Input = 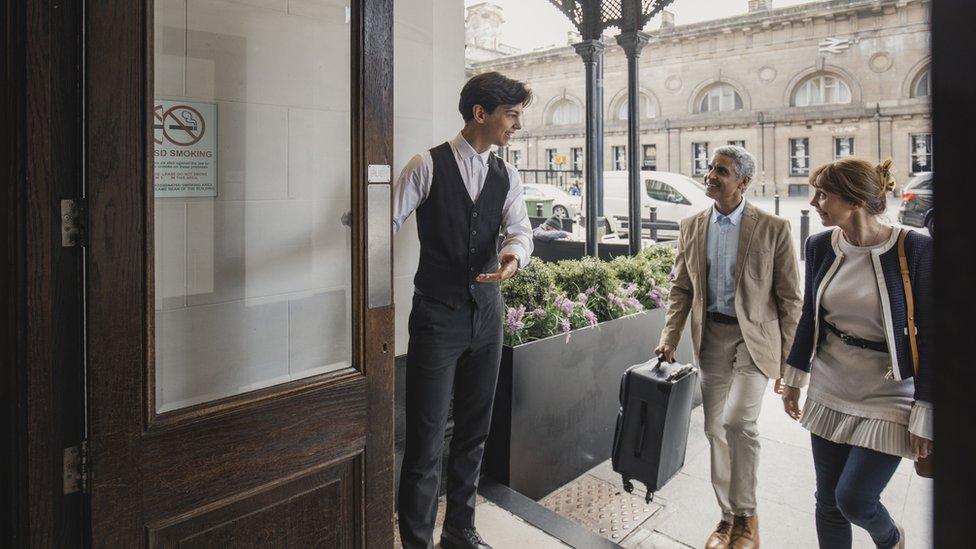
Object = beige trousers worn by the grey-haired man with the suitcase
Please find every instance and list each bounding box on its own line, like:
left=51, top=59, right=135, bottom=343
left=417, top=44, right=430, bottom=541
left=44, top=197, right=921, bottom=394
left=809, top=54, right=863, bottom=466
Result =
left=699, top=320, right=769, bottom=521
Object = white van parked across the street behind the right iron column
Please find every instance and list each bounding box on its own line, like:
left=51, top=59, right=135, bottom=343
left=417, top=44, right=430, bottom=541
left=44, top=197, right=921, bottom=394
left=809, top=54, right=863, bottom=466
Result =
left=603, top=170, right=712, bottom=231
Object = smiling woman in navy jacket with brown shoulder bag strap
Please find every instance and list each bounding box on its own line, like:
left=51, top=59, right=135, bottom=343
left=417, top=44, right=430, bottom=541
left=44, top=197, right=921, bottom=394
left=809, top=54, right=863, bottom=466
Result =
left=782, top=158, right=933, bottom=549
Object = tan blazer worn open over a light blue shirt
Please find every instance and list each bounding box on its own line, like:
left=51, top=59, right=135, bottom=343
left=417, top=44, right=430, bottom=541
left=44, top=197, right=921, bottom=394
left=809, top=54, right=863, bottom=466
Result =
left=661, top=202, right=803, bottom=379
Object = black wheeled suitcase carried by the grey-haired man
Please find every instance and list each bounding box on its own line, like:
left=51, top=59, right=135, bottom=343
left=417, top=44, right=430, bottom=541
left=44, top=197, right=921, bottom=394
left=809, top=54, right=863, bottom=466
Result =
left=611, top=357, right=698, bottom=501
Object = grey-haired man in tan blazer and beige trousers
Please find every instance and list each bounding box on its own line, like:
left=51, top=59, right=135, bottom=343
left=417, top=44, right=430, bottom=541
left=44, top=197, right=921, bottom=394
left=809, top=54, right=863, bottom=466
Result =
left=655, top=146, right=803, bottom=549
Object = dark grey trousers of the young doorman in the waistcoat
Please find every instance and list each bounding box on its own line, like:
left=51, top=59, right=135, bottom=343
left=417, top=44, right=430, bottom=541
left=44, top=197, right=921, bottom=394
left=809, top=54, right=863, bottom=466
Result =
left=397, top=294, right=504, bottom=549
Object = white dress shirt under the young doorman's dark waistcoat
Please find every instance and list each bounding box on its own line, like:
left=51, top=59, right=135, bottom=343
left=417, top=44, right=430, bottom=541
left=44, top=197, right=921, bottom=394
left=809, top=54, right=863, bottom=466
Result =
left=393, top=133, right=532, bottom=267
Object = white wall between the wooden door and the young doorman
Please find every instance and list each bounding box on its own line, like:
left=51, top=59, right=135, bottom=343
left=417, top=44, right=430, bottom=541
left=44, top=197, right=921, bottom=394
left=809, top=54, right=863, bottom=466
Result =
left=393, top=0, right=464, bottom=355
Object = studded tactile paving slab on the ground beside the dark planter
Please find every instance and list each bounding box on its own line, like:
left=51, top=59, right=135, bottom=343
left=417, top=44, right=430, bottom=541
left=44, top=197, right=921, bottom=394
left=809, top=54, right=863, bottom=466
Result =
left=541, top=475, right=661, bottom=542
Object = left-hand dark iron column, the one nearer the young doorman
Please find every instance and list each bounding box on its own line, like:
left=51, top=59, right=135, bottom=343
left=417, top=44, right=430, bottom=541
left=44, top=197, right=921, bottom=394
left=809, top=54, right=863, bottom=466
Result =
left=573, top=40, right=603, bottom=257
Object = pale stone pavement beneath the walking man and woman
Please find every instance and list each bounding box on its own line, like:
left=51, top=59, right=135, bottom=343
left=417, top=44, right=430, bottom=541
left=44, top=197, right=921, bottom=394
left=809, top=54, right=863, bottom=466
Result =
left=546, top=383, right=932, bottom=549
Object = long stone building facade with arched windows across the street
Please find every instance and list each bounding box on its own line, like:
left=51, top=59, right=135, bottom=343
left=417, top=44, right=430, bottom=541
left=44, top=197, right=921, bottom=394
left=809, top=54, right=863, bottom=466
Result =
left=468, top=0, right=933, bottom=195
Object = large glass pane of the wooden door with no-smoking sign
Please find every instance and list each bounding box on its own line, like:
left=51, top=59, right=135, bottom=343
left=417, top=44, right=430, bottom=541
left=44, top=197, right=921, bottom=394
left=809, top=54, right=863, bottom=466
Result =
left=153, top=0, right=352, bottom=413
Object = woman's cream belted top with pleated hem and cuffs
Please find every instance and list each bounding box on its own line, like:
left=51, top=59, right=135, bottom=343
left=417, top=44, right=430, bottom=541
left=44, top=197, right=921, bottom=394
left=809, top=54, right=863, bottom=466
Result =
left=784, top=225, right=932, bottom=458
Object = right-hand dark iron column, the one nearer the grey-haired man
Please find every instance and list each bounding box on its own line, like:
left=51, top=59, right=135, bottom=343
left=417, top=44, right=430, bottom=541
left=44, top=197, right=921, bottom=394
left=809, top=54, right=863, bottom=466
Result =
left=617, top=31, right=650, bottom=255
